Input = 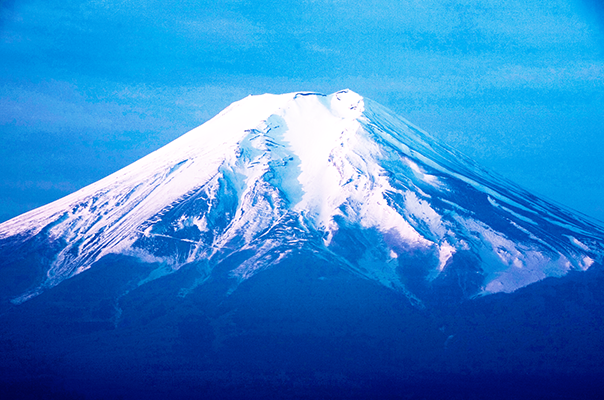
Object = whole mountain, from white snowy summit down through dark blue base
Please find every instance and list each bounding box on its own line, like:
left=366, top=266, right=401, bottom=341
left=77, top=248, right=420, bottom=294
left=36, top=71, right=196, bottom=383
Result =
left=0, top=90, right=604, bottom=398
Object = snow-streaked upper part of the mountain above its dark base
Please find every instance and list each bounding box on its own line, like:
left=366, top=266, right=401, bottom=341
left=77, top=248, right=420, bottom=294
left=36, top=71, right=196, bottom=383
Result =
left=0, top=90, right=604, bottom=304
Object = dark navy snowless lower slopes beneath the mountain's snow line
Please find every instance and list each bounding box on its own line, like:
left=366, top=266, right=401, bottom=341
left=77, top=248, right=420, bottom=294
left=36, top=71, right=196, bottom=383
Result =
left=0, top=256, right=604, bottom=400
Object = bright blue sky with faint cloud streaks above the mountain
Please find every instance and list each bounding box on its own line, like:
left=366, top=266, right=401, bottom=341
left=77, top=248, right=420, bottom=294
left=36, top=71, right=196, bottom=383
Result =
left=0, top=0, right=604, bottom=221
